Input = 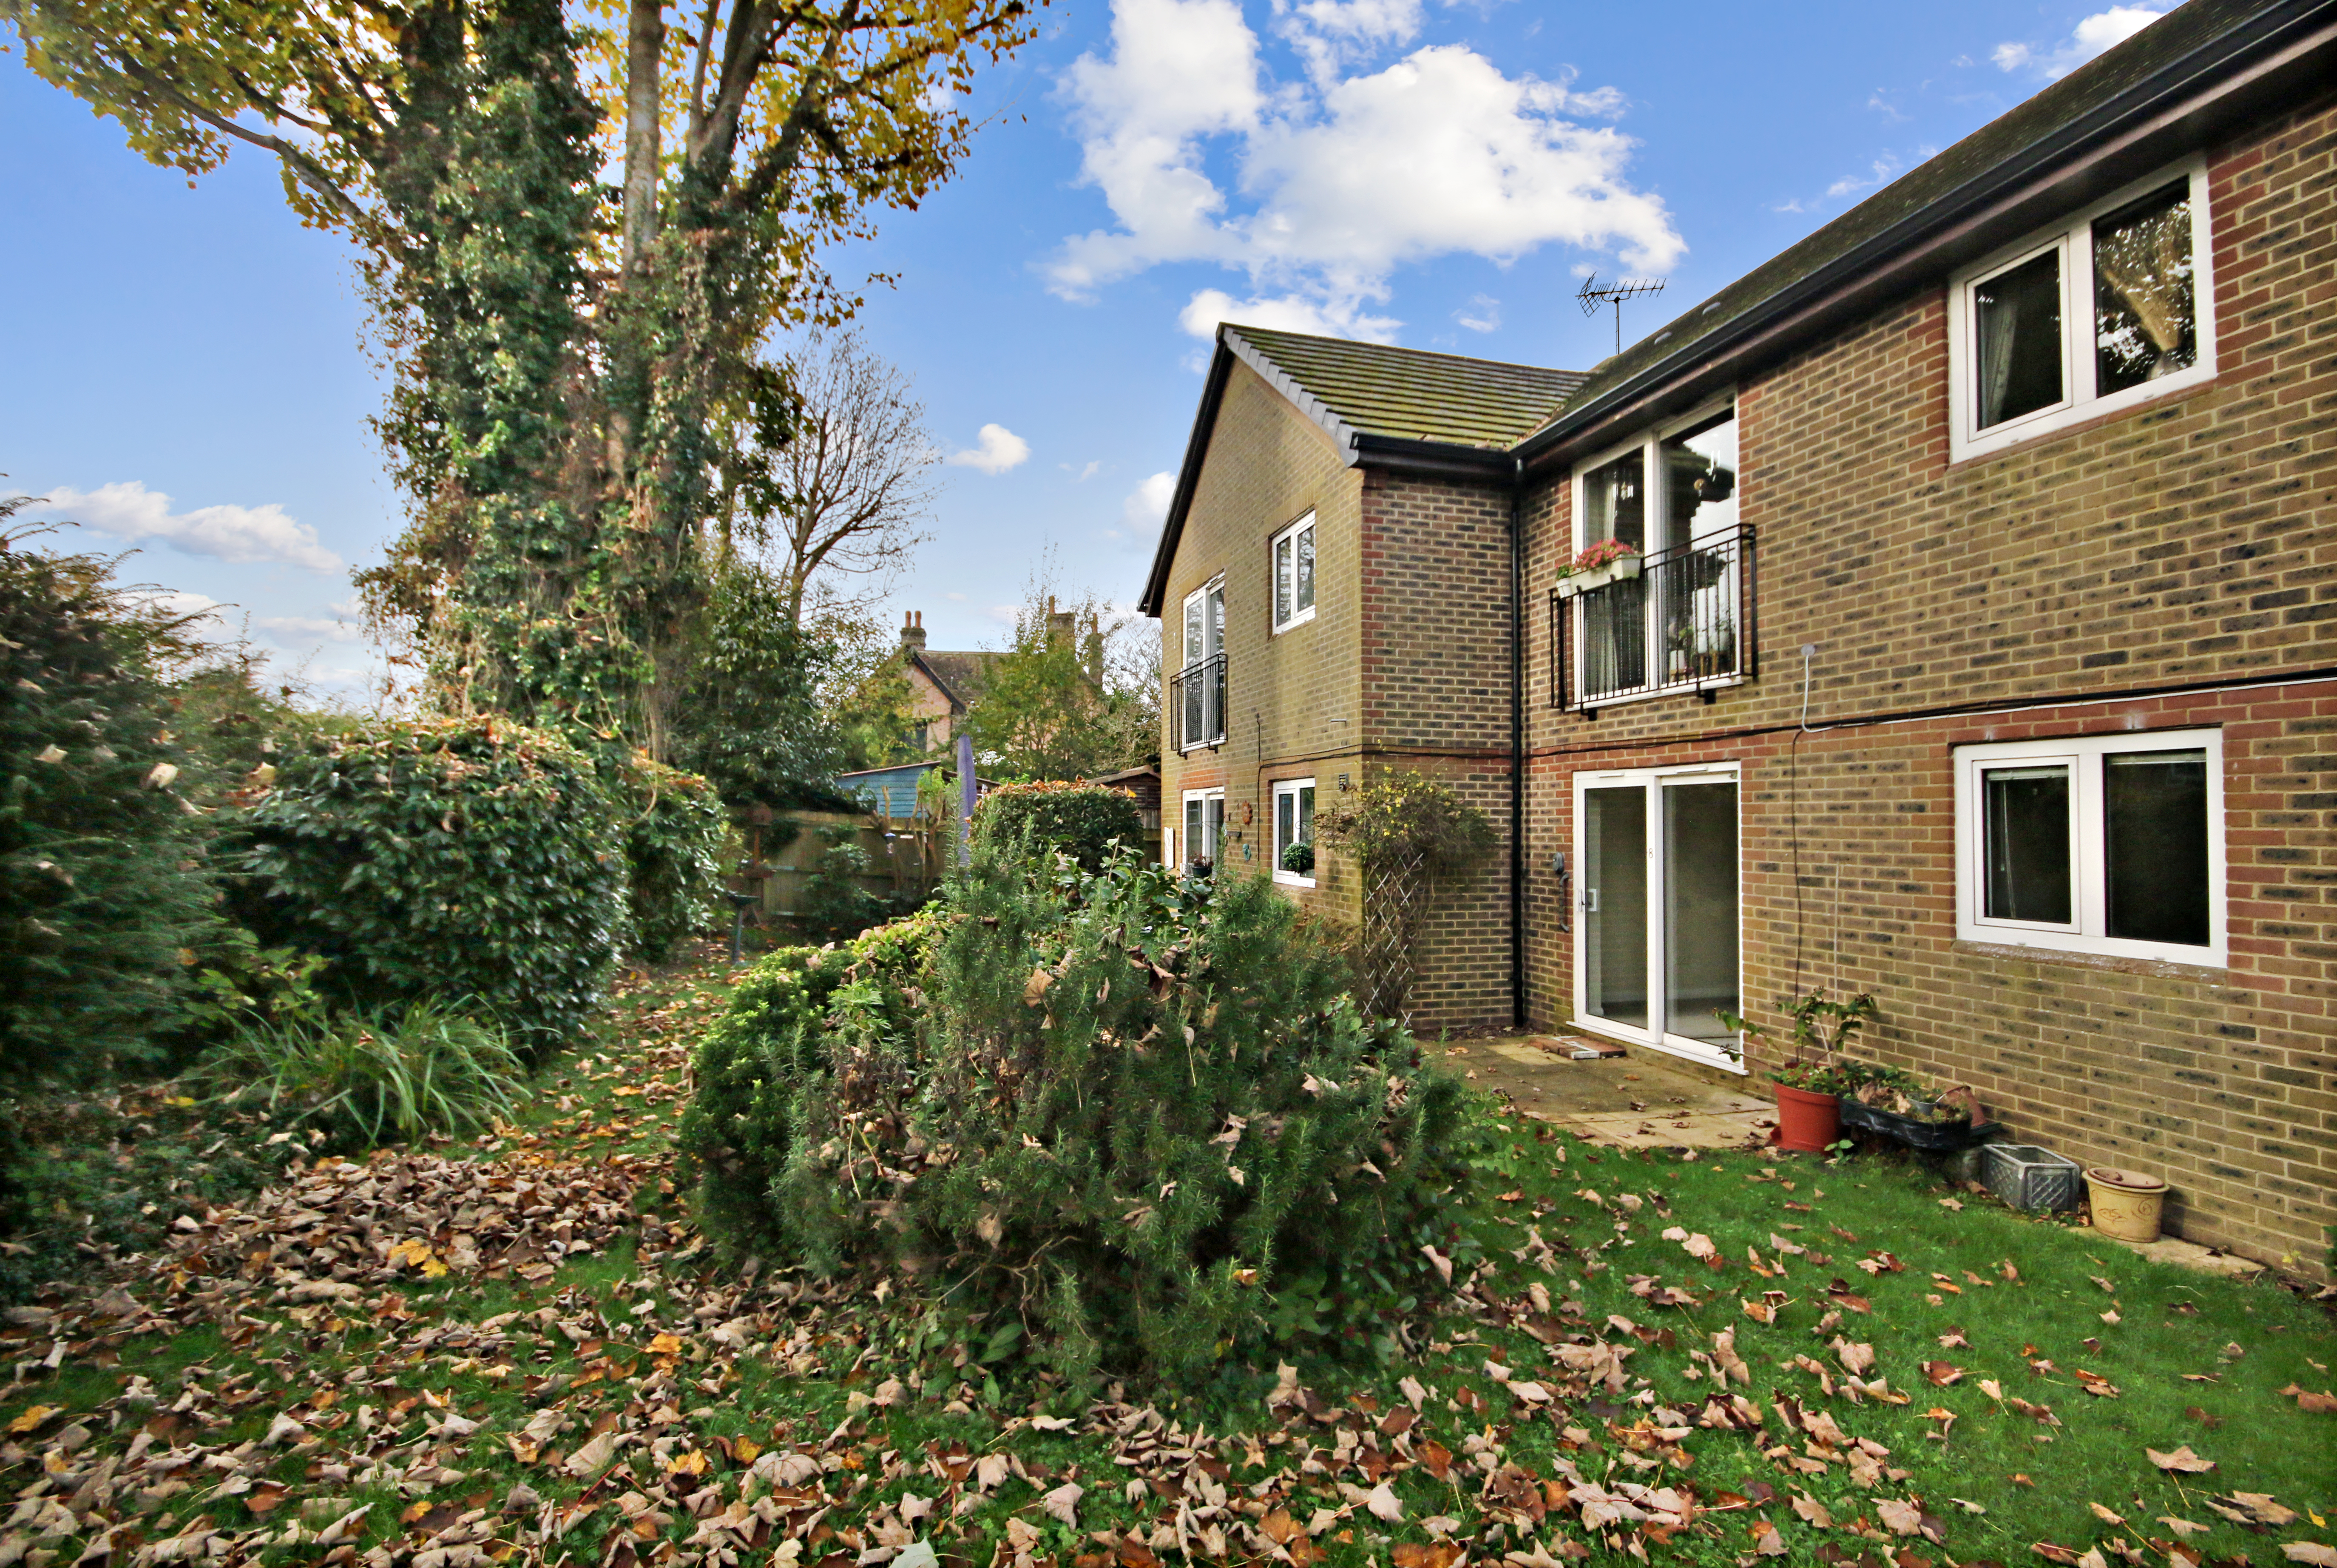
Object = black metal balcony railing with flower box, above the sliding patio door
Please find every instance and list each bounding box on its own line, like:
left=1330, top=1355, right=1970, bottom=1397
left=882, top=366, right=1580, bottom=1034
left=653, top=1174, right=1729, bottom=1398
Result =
left=1550, top=528, right=1760, bottom=713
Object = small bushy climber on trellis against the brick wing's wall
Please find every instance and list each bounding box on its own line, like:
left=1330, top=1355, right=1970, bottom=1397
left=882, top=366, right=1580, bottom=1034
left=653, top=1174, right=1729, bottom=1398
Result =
left=1316, top=769, right=1494, bottom=1017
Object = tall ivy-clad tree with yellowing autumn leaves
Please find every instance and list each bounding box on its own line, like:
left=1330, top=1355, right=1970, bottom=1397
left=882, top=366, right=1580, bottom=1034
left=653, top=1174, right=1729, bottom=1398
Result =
left=0, top=0, right=1031, bottom=753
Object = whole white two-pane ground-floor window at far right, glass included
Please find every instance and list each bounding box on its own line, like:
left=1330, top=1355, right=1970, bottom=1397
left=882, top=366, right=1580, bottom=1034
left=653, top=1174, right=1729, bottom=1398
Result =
left=1956, top=729, right=2229, bottom=967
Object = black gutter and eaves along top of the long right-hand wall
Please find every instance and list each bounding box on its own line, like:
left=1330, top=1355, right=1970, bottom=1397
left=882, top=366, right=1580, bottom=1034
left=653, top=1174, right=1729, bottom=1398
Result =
left=1514, top=0, right=2337, bottom=465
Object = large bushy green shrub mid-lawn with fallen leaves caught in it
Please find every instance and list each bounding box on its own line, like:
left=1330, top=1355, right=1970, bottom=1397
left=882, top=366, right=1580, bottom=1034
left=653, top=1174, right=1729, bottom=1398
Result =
left=685, top=844, right=1475, bottom=1376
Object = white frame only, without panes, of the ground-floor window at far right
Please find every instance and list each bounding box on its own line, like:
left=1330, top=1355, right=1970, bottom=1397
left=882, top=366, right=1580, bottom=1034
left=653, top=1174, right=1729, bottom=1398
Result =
left=1956, top=729, right=2232, bottom=970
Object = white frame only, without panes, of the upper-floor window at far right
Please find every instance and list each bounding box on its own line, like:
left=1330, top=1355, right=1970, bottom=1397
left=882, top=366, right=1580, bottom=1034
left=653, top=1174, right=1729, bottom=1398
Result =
left=1947, top=156, right=2215, bottom=463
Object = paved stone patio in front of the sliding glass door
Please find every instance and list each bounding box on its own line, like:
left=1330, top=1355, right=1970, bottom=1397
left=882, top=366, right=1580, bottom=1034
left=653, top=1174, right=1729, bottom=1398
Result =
left=1430, top=1035, right=1776, bottom=1150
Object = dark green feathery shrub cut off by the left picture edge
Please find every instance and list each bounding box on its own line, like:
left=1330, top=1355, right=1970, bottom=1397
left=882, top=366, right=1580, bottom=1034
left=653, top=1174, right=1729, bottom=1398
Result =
left=0, top=519, right=220, bottom=1087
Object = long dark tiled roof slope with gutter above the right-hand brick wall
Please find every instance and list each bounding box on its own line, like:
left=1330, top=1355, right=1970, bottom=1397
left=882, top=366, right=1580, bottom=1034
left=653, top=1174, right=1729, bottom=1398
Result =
left=1524, top=0, right=2337, bottom=458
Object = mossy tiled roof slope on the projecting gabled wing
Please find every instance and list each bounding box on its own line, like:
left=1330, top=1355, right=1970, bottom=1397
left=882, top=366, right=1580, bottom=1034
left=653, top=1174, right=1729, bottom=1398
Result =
left=1220, top=325, right=1582, bottom=451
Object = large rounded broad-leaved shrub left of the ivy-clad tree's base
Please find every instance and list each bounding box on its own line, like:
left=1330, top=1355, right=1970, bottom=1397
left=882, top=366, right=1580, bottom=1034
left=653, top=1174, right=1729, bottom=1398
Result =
left=236, top=717, right=626, bottom=1051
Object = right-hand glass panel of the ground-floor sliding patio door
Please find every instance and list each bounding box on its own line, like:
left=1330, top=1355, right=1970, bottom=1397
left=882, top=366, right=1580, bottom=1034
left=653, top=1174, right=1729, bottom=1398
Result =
left=1657, top=781, right=1744, bottom=1047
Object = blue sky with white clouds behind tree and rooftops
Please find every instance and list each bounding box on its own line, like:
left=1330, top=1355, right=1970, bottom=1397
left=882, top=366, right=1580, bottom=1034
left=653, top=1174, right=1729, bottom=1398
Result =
left=0, top=0, right=2167, bottom=685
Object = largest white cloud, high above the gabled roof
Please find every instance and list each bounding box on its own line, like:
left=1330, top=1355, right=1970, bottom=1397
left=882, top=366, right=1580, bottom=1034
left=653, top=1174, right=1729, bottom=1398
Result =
left=1047, top=0, right=1685, bottom=336
